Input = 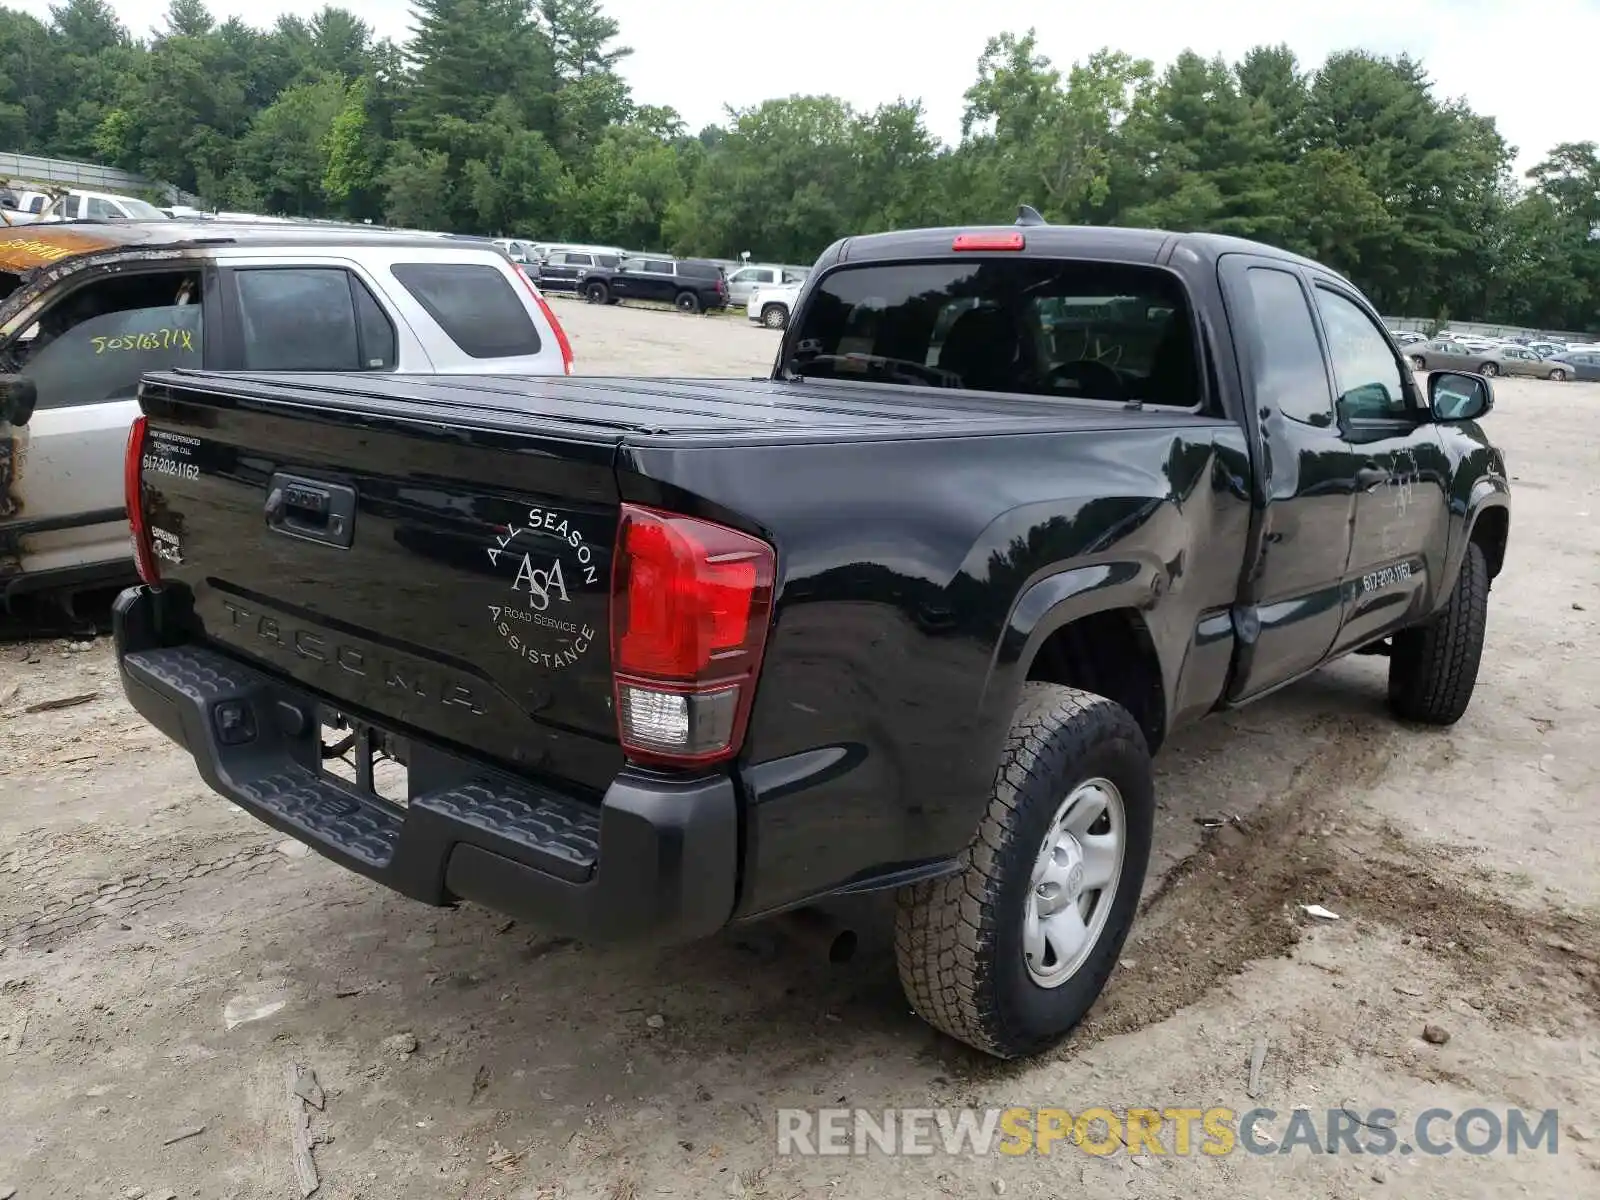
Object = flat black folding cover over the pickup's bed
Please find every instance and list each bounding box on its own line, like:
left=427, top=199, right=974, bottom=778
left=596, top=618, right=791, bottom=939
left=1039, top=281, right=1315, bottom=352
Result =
left=149, top=371, right=1211, bottom=445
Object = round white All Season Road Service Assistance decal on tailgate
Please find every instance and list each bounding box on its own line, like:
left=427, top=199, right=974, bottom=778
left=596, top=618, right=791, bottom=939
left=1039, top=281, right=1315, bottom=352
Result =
left=486, top=509, right=602, bottom=670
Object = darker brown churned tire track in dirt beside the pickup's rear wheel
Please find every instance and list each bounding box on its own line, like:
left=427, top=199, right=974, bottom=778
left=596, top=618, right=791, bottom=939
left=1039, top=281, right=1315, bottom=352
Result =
left=1066, top=717, right=1600, bottom=1053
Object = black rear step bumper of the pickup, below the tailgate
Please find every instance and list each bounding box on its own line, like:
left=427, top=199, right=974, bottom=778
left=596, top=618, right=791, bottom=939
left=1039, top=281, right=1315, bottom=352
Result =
left=114, top=587, right=739, bottom=942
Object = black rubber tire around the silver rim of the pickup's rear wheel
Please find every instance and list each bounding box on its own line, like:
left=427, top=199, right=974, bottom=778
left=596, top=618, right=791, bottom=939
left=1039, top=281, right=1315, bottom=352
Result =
left=894, top=683, right=1155, bottom=1058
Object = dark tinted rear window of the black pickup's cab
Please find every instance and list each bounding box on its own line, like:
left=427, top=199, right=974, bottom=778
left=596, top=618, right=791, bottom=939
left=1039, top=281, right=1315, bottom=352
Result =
left=784, top=259, right=1200, bottom=408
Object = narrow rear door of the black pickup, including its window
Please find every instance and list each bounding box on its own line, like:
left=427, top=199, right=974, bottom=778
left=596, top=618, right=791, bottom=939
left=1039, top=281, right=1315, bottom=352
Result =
left=1219, top=254, right=1355, bottom=702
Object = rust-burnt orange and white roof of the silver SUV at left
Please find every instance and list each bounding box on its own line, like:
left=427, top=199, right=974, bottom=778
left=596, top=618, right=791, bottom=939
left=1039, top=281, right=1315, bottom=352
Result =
left=0, top=218, right=459, bottom=272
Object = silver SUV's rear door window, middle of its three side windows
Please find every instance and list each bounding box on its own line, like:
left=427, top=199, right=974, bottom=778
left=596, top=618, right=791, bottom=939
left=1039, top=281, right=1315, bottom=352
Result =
left=234, top=267, right=395, bottom=371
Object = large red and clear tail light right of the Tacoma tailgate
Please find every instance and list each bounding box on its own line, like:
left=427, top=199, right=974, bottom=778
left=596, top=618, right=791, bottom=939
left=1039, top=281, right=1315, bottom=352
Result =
left=611, top=504, right=776, bottom=766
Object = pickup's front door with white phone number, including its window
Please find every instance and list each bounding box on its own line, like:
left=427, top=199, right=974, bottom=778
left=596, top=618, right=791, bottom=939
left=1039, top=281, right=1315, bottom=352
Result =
left=1312, top=278, right=1450, bottom=651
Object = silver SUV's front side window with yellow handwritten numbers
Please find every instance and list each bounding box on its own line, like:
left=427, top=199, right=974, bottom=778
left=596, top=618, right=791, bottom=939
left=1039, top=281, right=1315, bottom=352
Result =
left=9, top=272, right=205, bottom=408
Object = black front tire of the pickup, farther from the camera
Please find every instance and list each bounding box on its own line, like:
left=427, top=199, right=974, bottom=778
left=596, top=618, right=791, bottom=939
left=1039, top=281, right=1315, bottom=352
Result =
left=1389, top=542, right=1490, bottom=725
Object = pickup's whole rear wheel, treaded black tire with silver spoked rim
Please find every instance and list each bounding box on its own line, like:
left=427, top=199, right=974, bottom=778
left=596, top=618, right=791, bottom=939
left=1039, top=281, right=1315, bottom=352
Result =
left=894, top=683, right=1155, bottom=1058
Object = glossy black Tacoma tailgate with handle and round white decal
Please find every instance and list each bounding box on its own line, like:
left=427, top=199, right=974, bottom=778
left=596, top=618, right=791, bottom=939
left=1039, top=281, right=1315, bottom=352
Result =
left=141, top=374, right=622, bottom=792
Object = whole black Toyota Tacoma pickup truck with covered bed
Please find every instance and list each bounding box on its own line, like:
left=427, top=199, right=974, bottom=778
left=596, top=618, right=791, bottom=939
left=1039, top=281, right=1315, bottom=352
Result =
left=115, top=214, right=1509, bottom=1056
